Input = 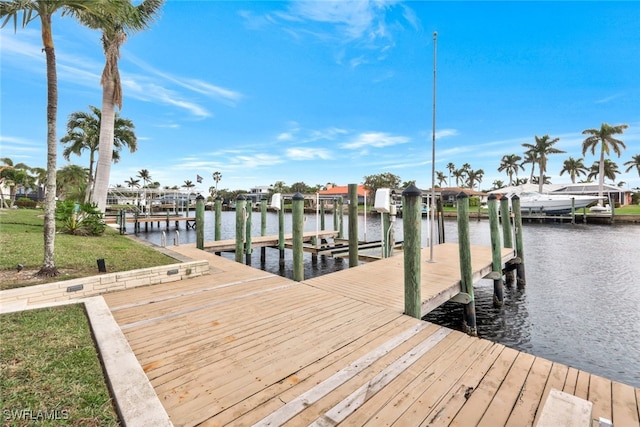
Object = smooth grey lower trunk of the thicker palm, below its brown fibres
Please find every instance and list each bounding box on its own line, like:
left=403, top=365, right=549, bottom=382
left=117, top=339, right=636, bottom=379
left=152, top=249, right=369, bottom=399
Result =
left=92, top=79, right=115, bottom=212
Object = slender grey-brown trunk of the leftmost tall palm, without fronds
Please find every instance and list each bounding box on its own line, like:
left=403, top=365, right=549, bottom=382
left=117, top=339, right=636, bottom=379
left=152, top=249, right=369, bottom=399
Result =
left=37, top=15, right=59, bottom=277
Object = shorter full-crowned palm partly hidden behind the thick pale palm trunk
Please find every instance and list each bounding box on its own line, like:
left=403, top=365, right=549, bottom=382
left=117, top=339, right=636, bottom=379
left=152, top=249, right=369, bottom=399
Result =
left=60, top=105, right=138, bottom=202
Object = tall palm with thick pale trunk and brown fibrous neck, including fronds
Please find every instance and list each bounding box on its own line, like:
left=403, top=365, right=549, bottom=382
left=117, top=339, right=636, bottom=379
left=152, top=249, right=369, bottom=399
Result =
left=90, top=0, right=164, bottom=211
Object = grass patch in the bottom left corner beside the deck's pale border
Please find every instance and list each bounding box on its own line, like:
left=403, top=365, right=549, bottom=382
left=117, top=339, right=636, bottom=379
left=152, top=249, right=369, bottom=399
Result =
left=0, top=304, right=120, bottom=426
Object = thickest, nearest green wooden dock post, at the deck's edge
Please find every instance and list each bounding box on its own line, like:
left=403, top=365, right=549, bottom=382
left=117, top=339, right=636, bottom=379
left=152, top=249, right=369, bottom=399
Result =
left=402, top=184, right=422, bottom=319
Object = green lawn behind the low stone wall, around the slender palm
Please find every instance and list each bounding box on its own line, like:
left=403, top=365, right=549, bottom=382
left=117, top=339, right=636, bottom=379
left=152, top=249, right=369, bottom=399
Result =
left=0, top=209, right=176, bottom=290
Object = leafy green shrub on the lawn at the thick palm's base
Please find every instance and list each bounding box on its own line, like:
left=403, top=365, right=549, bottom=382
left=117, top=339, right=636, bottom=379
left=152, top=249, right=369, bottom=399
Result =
left=56, top=200, right=106, bottom=236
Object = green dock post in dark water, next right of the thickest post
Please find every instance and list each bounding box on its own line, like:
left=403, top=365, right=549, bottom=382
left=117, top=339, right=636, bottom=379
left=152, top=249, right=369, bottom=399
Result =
left=457, top=192, right=478, bottom=337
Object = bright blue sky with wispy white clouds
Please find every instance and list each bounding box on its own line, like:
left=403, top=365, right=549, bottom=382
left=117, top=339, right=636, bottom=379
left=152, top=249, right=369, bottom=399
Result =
left=0, top=0, right=640, bottom=192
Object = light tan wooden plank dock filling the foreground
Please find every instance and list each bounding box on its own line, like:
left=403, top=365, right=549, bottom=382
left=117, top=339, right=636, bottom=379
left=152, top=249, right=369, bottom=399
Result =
left=104, top=244, right=640, bottom=426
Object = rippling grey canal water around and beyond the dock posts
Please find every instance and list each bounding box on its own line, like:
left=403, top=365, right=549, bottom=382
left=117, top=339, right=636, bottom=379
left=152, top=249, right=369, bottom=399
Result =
left=128, top=211, right=640, bottom=387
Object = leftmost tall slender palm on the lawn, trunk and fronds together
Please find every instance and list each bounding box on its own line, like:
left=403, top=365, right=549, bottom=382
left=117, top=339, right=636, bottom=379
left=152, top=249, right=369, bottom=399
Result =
left=0, top=0, right=120, bottom=277
